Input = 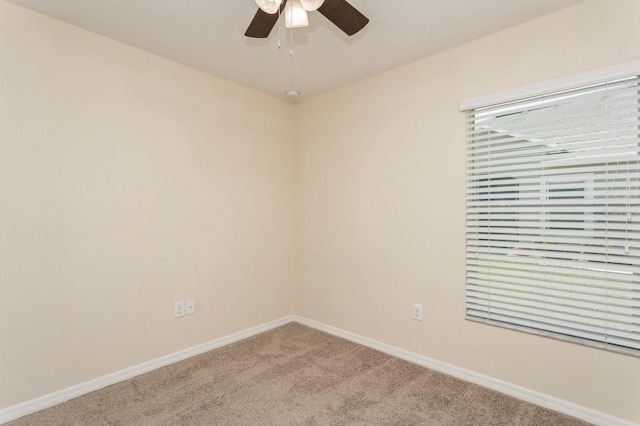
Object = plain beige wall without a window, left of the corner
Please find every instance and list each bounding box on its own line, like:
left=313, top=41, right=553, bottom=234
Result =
left=0, top=1, right=294, bottom=408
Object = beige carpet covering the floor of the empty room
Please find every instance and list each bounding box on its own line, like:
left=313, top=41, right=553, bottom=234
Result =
left=9, top=323, right=587, bottom=426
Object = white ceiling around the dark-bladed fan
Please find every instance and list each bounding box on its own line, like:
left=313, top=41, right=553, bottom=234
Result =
left=9, top=0, right=584, bottom=99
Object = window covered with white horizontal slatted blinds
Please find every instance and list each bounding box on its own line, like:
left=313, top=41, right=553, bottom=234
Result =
left=463, top=65, right=640, bottom=355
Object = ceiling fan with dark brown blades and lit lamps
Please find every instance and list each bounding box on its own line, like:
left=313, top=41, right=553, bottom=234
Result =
left=244, top=0, right=369, bottom=38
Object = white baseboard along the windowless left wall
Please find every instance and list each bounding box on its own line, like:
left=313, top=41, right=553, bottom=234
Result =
left=0, top=316, right=295, bottom=424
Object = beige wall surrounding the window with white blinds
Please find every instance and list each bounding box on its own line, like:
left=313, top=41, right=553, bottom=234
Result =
left=296, top=0, right=640, bottom=423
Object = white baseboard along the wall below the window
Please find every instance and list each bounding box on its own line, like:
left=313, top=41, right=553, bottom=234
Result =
left=294, top=316, right=637, bottom=426
